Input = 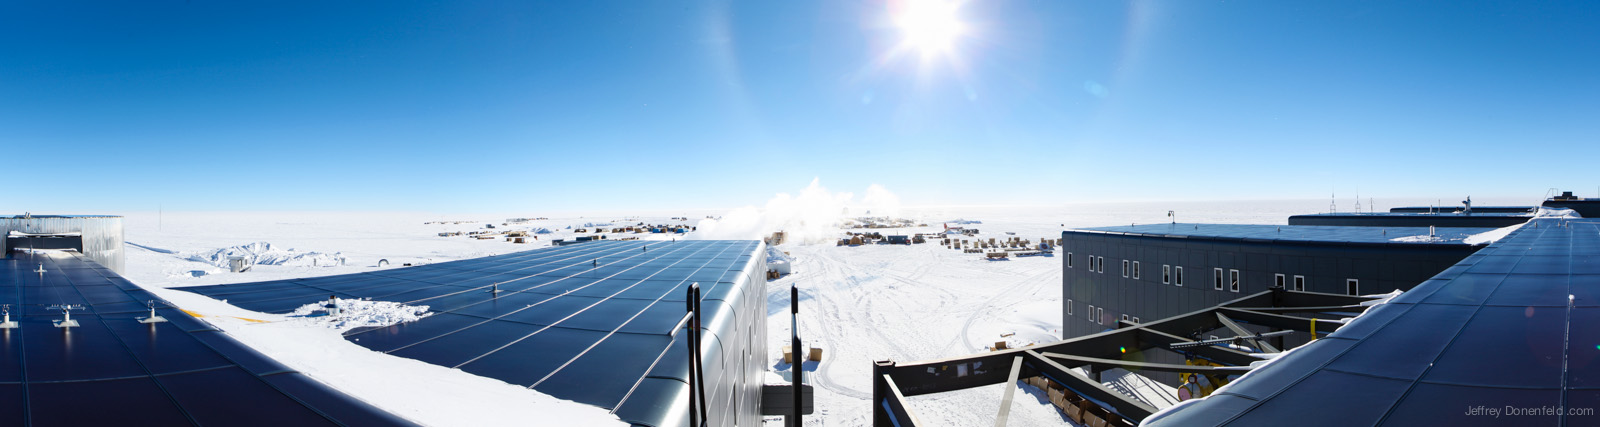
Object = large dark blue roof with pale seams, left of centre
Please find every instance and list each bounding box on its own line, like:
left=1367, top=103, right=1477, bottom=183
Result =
left=186, top=240, right=765, bottom=425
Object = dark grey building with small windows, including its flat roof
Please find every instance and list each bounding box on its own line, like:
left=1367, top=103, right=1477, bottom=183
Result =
left=1058, top=224, right=1493, bottom=384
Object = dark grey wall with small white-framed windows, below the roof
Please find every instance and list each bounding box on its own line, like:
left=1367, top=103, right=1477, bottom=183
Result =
left=1056, top=232, right=1482, bottom=385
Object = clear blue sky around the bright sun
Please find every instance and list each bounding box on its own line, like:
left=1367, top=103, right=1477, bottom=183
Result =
left=0, top=0, right=1600, bottom=213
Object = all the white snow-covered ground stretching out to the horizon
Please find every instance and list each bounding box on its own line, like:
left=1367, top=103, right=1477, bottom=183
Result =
left=103, top=195, right=1528, bottom=425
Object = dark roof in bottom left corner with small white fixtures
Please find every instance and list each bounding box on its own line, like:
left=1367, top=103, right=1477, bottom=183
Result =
left=0, top=253, right=411, bottom=425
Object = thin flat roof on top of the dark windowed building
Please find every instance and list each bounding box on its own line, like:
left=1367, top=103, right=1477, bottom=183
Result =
left=1067, top=222, right=1494, bottom=245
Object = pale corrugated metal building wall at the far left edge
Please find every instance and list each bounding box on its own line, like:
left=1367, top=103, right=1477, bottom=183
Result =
left=0, top=216, right=123, bottom=273
